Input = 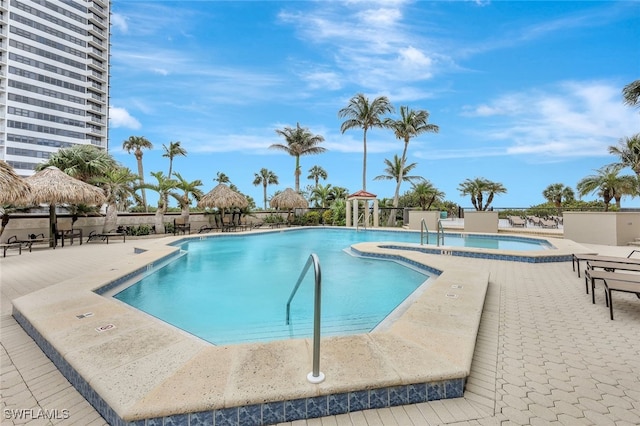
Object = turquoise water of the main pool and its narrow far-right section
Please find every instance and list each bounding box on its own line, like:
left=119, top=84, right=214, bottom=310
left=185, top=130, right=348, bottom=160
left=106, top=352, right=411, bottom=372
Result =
left=114, top=228, right=552, bottom=344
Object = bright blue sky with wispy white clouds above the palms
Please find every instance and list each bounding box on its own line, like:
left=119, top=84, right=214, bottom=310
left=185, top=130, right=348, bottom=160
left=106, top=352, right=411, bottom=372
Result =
left=109, top=0, right=640, bottom=207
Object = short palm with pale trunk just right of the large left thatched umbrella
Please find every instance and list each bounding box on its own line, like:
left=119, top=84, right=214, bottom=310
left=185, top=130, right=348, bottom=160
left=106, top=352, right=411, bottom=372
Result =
left=94, top=167, right=139, bottom=232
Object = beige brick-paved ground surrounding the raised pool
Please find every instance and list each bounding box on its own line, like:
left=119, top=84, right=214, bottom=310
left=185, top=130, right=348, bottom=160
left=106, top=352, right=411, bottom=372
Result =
left=0, top=235, right=640, bottom=426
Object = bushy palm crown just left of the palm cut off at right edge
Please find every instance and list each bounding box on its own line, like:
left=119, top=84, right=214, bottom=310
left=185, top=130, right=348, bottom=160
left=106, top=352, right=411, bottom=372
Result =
left=576, top=164, right=638, bottom=211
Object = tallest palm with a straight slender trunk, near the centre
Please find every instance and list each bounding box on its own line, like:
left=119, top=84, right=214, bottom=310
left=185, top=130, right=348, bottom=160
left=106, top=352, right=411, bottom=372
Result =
left=338, top=93, right=393, bottom=191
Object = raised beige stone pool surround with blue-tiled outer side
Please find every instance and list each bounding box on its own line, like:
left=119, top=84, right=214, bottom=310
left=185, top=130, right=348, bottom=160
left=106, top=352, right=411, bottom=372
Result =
left=8, top=228, right=592, bottom=424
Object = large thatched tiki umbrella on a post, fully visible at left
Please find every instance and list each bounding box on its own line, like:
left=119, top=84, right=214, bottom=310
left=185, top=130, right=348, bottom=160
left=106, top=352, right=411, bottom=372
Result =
left=26, top=166, right=106, bottom=247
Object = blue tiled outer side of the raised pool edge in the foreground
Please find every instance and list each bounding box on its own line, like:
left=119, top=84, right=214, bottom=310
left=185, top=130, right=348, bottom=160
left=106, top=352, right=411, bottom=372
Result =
left=13, top=308, right=466, bottom=426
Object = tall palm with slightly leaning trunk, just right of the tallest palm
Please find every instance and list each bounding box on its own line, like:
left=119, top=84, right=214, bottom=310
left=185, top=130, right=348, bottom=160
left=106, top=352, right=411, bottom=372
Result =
left=384, top=106, right=440, bottom=213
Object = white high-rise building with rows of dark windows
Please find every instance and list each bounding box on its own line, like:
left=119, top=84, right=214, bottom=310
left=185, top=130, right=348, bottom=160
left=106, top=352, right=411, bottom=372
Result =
left=0, top=0, right=110, bottom=176
